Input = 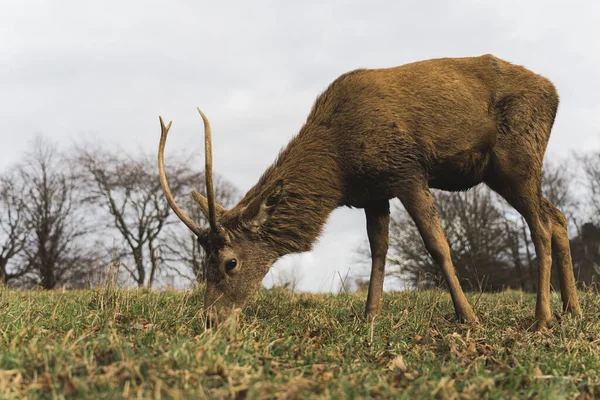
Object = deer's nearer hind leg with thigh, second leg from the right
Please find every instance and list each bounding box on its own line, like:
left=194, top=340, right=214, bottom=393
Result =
left=486, top=175, right=553, bottom=330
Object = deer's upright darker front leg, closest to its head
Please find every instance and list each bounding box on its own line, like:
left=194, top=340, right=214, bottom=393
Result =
left=365, top=200, right=390, bottom=319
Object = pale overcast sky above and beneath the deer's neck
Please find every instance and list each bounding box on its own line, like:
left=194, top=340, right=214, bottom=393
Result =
left=0, top=0, right=600, bottom=291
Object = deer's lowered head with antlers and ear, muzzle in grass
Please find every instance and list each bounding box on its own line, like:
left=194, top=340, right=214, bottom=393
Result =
left=158, top=109, right=283, bottom=326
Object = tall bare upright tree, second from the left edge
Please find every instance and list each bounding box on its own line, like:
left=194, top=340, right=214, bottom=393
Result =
left=19, top=138, right=96, bottom=289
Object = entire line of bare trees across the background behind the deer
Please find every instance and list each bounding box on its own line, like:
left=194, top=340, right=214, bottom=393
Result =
left=0, top=137, right=600, bottom=291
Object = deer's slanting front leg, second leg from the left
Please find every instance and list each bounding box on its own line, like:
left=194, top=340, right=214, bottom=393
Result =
left=399, top=185, right=477, bottom=323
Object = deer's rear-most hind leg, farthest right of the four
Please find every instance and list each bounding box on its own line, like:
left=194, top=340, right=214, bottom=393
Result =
left=542, top=198, right=581, bottom=316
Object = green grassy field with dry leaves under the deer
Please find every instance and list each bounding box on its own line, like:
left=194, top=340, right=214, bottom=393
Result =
left=0, top=288, right=600, bottom=399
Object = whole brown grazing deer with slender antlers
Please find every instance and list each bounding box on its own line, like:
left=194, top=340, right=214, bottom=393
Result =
left=158, top=54, right=581, bottom=329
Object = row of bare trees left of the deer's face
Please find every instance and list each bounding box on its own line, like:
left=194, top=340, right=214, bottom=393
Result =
left=0, top=137, right=239, bottom=289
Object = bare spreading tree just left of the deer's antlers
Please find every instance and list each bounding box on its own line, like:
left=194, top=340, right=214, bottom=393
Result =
left=77, top=148, right=217, bottom=287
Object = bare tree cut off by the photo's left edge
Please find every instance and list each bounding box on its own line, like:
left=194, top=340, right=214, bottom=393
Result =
left=0, top=173, right=29, bottom=284
